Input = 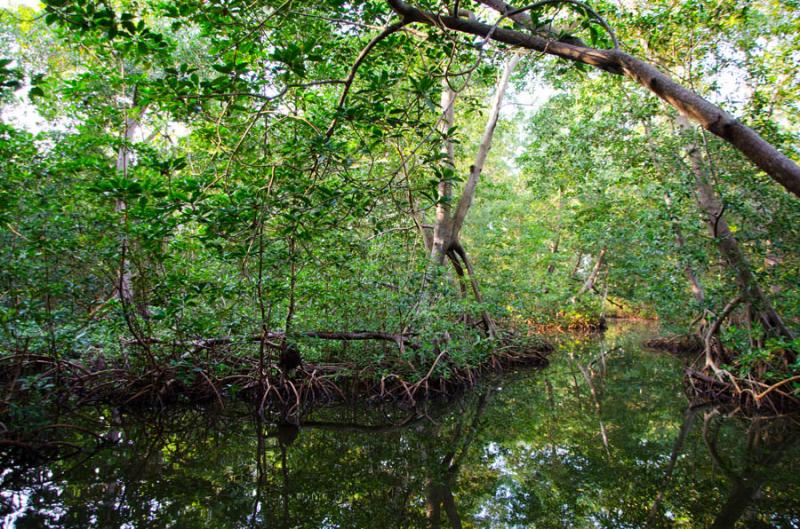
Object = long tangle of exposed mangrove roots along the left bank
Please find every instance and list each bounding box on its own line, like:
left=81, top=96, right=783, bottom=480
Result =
left=0, top=341, right=552, bottom=444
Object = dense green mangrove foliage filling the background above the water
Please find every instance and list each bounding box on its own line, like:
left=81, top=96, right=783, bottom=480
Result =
left=0, top=0, right=800, bottom=375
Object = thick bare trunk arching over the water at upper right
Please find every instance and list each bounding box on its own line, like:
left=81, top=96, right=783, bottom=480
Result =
left=387, top=0, right=800, bottom=197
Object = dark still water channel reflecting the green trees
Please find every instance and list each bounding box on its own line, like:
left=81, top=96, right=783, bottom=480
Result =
left=0, top=325, right=800, bottom=529
